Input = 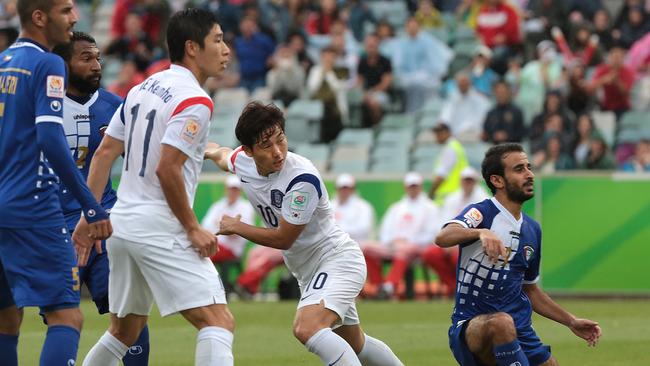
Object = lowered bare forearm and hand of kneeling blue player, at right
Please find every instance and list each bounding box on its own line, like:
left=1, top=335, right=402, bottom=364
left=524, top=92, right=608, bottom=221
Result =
left=523, top=284, right=602, bottom=346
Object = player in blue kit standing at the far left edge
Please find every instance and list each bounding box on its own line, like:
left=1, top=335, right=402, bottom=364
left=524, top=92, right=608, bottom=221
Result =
left=0, top=0, right=112, bottom=366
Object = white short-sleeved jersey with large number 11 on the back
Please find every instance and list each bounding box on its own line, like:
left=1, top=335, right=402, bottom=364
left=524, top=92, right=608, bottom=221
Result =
left=106, top=65, right=213, bottom=248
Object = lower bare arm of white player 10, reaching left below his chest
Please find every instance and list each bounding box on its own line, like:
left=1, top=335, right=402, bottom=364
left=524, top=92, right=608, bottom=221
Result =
left=217, top=215, right=307, bottom=250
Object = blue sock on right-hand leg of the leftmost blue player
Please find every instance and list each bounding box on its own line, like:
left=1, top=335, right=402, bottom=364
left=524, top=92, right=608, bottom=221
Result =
left=40, top=325, right=79, bottom=366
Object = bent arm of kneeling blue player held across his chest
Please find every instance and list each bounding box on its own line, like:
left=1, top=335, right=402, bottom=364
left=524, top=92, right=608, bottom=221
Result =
left=436, top=223, right=507, bottom=263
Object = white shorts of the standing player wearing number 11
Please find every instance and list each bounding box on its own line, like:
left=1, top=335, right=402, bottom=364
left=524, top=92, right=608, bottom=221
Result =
left=106, top=236, right=226, bottom=318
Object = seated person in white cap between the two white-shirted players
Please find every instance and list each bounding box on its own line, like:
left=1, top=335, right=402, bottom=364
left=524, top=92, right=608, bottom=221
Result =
left=201, top=175, right=255, bottom=264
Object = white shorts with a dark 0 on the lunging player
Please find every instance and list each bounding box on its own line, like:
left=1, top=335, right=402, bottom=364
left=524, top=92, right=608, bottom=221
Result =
left=298, top=241, right=366, bottom=328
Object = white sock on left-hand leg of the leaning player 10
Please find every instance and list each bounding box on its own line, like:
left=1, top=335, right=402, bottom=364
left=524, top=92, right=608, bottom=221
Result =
left=305, top=328, right=361, bottom=366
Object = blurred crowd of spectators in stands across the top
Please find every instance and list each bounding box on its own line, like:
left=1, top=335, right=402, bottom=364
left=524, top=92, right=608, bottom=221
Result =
left=0, top=0, right=650, bottom=176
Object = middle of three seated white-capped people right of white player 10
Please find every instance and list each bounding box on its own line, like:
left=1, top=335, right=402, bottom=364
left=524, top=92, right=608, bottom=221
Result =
left=363, top=172, right=442, bottom=297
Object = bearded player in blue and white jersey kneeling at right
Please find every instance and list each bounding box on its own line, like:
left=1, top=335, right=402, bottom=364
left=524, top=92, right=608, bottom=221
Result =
left=436, top=143, right=601, bottom=366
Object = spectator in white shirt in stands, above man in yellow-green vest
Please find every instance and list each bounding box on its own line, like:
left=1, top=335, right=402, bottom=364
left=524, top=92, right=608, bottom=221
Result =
left=439, top=71, right=492, bottom=142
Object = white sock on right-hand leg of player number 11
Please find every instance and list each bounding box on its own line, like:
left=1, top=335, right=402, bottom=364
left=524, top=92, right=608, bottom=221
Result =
left=194, top=327, right=235, bottom=366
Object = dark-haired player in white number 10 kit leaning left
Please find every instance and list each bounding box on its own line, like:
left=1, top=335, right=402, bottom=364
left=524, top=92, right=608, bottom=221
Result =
left=206, top=102, right=402, bottom=366
